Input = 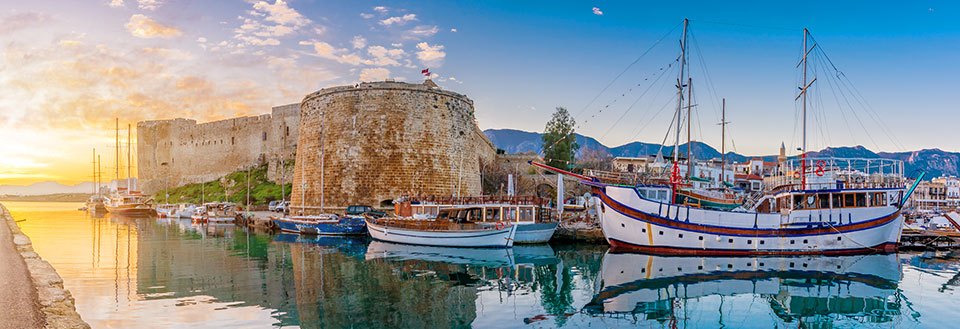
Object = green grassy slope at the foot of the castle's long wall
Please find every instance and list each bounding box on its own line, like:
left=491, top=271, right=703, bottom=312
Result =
left=153, top=165, right=292, bottom=205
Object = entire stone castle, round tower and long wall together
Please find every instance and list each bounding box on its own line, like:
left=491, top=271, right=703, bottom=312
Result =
left=137, top=80, right=496, bottom=210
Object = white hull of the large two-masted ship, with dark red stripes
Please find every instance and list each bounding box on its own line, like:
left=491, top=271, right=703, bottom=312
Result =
left=600, top=186, right=903, bottom=255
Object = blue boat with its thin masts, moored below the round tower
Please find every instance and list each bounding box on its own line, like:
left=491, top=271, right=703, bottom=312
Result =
left=272, top=107, right=367, bottom=235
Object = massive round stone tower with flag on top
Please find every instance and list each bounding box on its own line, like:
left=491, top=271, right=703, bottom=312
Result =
left=290, top=80, right=496, bottom=214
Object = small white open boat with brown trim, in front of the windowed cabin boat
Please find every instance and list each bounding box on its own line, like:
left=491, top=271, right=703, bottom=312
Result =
left=366, top=207, right=520, bottom=248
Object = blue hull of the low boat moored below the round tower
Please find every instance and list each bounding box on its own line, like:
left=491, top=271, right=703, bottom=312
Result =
left=272, top=214, right=367, bottom=235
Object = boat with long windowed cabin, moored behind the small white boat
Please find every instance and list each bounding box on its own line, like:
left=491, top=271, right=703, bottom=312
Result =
left=394, top=196, right=559, bottom=244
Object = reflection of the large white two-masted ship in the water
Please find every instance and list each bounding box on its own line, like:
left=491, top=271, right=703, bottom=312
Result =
left=584, top=253, right=901, bottom=327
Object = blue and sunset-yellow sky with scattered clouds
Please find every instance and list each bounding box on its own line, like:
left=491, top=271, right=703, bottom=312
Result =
left=0, top=0, right=960, bottom=184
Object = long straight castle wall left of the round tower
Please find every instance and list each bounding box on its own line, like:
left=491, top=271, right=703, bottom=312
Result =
left=137, top=104, right=300, bottom=193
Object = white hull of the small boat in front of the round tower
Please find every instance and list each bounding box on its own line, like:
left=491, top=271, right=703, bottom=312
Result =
left=367, top=220, right=517, bottom=248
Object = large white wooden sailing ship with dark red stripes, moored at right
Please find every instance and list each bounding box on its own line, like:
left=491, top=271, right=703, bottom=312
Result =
left=538, top=20, right=924, bottom=256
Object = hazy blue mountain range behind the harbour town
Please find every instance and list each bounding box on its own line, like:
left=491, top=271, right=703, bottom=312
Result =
left=483, top=129, right=960, bottom=179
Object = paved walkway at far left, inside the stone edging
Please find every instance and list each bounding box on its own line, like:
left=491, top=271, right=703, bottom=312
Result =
left=0, top=206, right=44, bottom=329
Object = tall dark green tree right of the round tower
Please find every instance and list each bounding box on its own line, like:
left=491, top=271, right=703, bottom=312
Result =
left=543, top=106, right=580, bottom=170
